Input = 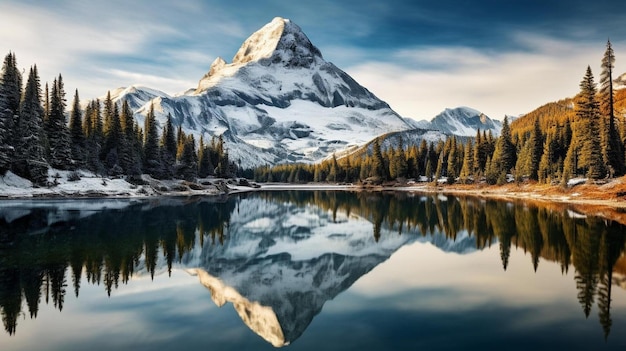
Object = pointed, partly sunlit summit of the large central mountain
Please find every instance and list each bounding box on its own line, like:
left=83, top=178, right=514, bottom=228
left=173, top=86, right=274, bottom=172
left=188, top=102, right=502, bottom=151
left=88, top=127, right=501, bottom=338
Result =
left=233, top=17, right=322, bottom=67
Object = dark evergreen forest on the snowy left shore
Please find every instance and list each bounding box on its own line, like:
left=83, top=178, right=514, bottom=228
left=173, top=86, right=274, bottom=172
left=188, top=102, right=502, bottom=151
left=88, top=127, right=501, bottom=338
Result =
left=0, top=53, right=237, bottom=186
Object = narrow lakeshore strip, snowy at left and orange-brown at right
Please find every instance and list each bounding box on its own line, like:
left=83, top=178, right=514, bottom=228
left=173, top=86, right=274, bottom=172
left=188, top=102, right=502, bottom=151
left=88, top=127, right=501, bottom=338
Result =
left=0, top=170, right=626, bottom=224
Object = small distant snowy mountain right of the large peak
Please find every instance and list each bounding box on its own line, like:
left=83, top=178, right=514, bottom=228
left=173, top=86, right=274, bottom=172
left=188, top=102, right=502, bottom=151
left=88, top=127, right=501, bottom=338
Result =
left=410, top=107, right=502, bottom=137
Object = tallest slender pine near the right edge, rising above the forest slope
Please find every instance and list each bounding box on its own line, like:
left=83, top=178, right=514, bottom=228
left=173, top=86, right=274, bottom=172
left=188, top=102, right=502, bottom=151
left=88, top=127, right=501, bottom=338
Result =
left=599, top=41, right=626, bottom=176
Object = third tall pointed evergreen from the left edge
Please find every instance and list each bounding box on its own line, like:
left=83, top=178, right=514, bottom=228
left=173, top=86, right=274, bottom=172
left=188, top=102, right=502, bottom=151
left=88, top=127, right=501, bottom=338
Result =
left=48, top=74, right=72, bottom=169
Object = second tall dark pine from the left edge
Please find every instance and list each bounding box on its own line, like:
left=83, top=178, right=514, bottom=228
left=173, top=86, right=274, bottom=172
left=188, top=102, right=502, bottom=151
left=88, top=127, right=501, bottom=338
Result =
left=14, top=66, right=48, bottom=185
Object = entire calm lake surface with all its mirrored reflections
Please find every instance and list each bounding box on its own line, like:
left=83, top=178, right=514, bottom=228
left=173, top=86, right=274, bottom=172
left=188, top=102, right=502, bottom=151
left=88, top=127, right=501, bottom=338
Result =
left=0, top=191, right=626, bottom=351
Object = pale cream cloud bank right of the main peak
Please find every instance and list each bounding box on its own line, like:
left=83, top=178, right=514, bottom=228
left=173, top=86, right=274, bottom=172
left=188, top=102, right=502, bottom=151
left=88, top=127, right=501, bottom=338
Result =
left=347, top=34, right=626, bottom=119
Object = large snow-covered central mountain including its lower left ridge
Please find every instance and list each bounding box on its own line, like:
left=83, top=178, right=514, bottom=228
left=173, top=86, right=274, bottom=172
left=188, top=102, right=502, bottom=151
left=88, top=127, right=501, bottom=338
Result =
left=106, top=17, right=412, bottom=167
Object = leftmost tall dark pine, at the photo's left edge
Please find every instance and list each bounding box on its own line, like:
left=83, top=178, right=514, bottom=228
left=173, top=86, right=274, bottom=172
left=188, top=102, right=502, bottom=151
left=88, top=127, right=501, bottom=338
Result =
left=0, top=53, right=22, bottom=174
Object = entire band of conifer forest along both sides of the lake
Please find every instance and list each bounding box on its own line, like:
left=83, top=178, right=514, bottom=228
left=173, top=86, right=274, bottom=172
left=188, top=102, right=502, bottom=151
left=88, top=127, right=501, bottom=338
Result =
left=0, top=41, right=626, bottom=186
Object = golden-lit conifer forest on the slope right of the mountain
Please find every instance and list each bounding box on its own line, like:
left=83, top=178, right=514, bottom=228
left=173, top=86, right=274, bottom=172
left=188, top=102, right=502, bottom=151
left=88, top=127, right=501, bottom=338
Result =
left=254, top=41, right=626, bottom=185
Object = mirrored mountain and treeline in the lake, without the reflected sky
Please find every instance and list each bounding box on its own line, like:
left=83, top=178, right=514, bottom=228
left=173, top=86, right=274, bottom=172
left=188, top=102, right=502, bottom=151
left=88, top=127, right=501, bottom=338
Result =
left=0, top=191, right=626, bottom=347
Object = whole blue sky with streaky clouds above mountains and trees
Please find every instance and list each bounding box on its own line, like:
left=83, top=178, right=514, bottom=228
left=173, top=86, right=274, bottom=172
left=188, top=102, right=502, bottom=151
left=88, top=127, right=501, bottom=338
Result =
left=0, top=0, right=626, bottom=119
